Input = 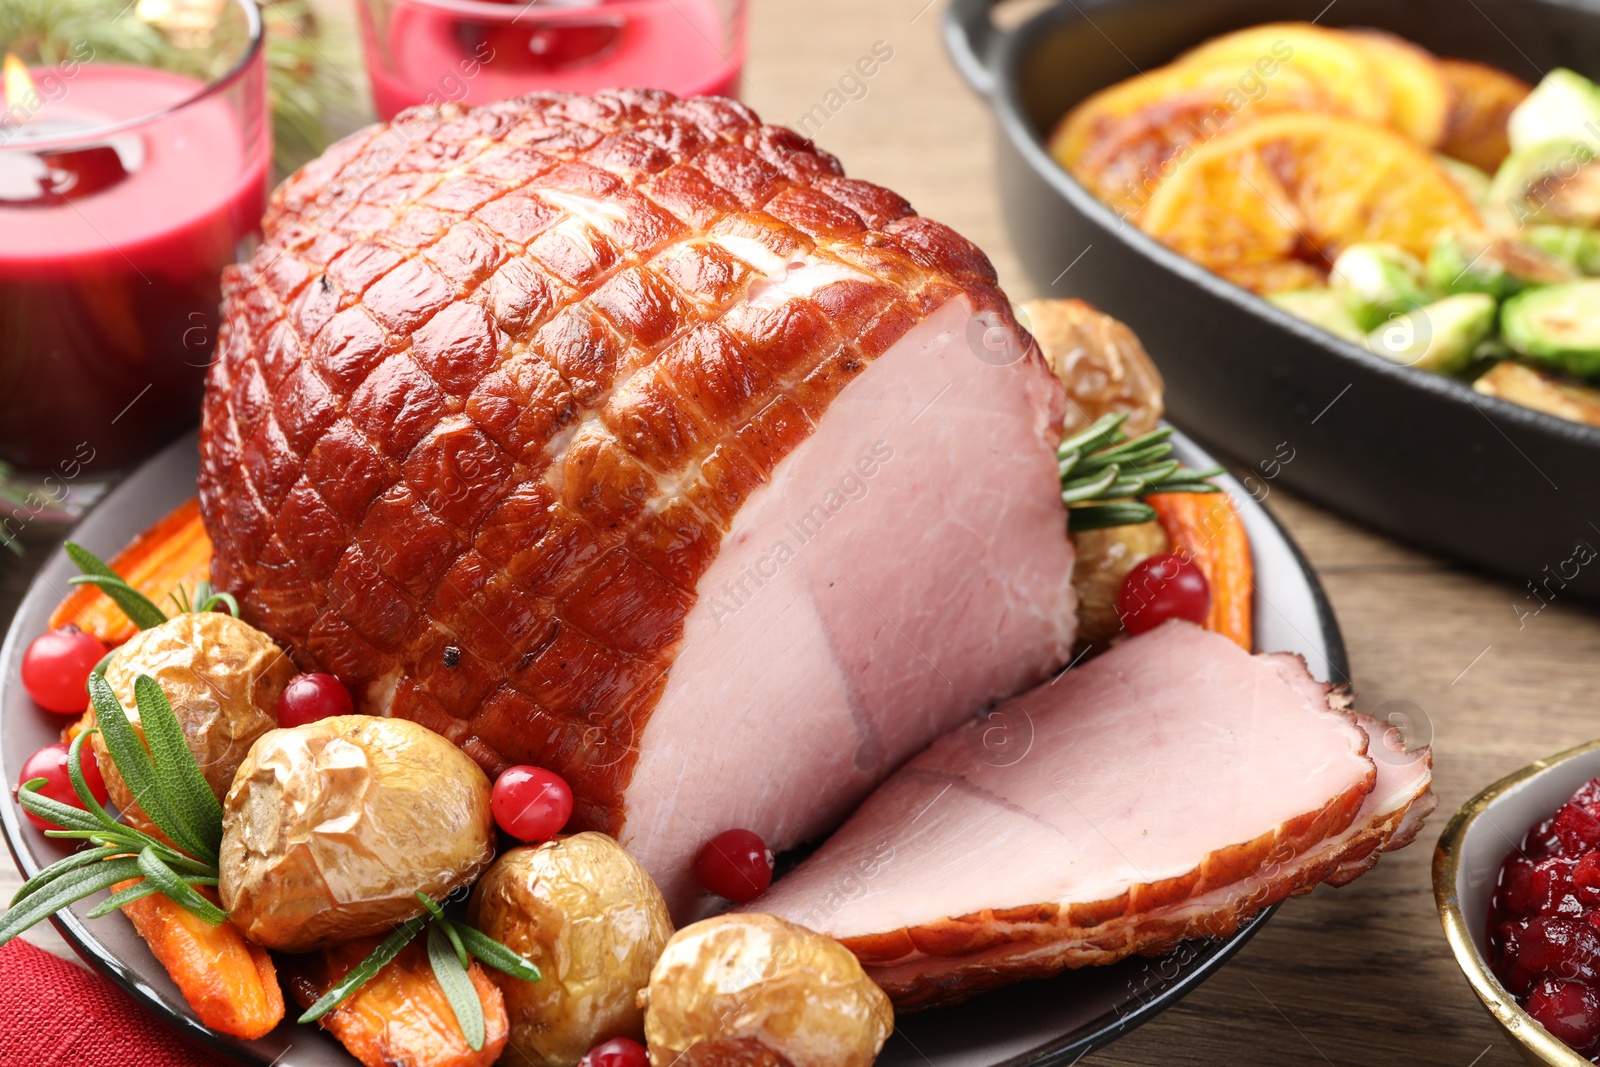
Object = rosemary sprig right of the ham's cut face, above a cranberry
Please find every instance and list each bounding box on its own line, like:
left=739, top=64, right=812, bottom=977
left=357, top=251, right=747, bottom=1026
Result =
left=1056, top=414, right=1222, bottom=533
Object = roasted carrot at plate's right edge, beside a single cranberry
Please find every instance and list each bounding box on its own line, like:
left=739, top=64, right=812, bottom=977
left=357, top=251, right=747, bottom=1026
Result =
left=1144, top=493, right=1256, bottom=653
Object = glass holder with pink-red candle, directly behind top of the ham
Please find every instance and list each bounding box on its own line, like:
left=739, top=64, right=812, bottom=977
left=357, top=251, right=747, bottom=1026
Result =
left=360, top=0, right=744, bottom=118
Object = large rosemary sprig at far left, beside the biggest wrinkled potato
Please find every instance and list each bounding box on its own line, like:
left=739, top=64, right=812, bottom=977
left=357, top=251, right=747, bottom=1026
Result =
left=0, top=675, right=227, bottom=945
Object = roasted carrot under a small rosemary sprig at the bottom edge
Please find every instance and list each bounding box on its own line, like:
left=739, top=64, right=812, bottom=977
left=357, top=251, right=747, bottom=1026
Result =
left=290, top=936, right=510, bottom=1067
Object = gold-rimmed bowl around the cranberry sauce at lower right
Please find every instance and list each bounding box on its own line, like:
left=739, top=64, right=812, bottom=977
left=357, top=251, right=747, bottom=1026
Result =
left=1434, top=741, right=1600, bottom=1067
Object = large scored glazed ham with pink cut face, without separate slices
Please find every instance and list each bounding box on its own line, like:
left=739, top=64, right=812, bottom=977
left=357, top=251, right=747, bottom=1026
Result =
left=200, top=91, right=1074, bottom=917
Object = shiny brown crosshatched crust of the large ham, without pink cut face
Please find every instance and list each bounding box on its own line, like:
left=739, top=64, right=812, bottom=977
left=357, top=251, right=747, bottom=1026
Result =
left=200, top=91, right=1072, bottom=857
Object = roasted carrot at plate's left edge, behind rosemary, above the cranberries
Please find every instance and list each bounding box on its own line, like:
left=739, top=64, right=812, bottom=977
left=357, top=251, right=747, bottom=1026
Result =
left=50, top=498, right=211, bottom=645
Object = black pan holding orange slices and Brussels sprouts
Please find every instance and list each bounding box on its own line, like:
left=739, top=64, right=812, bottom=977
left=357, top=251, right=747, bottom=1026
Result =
left=946, top=0, right=1600, bottom=600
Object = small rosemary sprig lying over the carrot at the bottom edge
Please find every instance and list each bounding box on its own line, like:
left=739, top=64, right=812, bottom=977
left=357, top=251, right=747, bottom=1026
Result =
left=299, top=893, right=541, bottom=1051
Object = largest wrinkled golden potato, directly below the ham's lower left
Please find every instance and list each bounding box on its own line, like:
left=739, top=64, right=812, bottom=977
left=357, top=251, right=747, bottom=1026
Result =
left=219, top=715, right=494, bottom=952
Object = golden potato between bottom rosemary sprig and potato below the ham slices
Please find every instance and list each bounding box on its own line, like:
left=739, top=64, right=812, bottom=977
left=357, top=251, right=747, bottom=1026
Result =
left=467, top=833, right=672, bottom=1067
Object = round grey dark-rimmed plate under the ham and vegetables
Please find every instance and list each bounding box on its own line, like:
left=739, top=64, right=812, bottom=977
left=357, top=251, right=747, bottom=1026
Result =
left=0, top=435, right=1349, bottom=1067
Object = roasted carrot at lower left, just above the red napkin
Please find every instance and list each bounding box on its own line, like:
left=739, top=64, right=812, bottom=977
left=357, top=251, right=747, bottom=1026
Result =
left=112, top=878, right=283, bottom=1040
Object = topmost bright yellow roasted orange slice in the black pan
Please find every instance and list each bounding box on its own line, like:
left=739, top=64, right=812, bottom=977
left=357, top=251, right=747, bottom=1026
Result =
left=1173, top=22, right=1394, bottom=125
